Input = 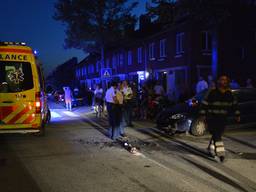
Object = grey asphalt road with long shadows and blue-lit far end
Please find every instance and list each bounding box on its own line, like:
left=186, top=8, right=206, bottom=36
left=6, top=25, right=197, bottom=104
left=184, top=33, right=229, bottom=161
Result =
left=0, top=105, right=256, bottom=192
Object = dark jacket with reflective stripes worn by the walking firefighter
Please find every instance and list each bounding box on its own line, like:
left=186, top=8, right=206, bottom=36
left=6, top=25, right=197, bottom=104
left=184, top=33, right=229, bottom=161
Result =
left=200, top=89, right=240, bottom=117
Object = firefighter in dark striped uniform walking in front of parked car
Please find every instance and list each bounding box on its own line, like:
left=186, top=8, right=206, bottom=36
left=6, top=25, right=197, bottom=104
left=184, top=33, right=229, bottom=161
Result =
left=200, top=75, right=240, bottom=162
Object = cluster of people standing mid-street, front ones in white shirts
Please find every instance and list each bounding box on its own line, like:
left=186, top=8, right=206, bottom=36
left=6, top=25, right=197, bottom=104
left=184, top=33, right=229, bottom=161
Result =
left=93, top=80, right=166, bottom=139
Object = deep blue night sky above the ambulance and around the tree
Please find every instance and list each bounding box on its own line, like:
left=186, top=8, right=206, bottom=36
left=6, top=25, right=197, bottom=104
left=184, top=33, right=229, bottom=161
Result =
left=0, top=0, right=146, bottom=74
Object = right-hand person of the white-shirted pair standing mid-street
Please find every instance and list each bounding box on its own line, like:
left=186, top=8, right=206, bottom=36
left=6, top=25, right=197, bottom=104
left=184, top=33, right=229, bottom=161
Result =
left=121, top=81, right=133, bottom=127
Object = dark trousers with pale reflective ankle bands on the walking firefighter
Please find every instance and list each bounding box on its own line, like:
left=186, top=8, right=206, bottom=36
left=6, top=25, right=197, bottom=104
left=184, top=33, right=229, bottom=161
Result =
left=207, top=117, right=226, bottom=156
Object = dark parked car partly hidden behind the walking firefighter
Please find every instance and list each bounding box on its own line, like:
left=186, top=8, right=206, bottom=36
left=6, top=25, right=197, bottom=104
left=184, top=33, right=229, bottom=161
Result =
left=156, top=88, right=256, bottom=136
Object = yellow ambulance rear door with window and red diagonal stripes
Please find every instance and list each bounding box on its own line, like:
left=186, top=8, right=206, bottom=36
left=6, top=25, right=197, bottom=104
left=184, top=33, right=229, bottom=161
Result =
left=0, top=61, right=35, bottom=128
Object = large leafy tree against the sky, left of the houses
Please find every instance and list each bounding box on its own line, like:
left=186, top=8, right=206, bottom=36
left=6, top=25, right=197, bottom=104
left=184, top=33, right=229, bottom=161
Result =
left=53, top=0, right=138, bottom=65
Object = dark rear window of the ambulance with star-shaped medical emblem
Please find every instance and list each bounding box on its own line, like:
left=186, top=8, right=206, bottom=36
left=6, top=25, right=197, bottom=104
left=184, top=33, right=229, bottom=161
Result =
left=0, top=61, right=34, bottom=93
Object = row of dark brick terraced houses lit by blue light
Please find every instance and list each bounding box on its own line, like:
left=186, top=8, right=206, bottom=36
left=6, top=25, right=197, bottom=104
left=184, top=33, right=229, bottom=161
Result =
left=76, top=6, right=256, bottom=99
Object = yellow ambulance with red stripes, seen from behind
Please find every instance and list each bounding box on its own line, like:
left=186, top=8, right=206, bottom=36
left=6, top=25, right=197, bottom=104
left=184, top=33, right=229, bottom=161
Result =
left=0, top=42, right=50, bottom=135
